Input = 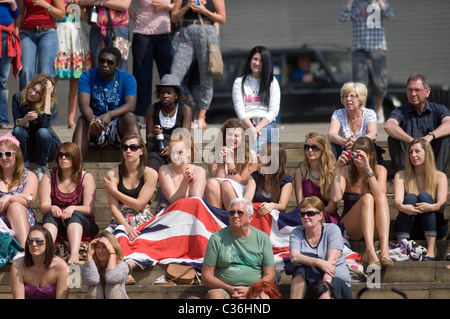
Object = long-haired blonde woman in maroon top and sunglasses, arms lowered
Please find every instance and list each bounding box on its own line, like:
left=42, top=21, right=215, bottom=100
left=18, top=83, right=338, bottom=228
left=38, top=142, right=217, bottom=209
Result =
left=294, top=132, right=340, bottom=224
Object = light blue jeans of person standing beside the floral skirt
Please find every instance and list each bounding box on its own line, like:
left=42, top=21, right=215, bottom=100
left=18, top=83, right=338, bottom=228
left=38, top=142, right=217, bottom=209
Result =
left=19, top=29, right=58, bottom=91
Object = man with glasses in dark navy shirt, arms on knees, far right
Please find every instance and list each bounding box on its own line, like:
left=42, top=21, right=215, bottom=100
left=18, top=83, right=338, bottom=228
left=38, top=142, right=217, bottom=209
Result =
left=384, top=74, right=450, bottom=172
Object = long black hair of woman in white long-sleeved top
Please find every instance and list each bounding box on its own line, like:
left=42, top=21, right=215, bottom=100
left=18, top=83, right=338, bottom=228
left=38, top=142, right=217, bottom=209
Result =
left=241, top=45, right=273, bottom=107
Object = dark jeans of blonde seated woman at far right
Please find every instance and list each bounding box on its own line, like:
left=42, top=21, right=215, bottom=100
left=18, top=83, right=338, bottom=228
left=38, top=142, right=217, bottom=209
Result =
left=396, top=192, right=437, bottom=239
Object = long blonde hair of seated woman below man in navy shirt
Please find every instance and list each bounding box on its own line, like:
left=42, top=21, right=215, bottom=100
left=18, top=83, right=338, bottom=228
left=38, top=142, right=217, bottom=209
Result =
left=405, top=138, right=436, bottom=199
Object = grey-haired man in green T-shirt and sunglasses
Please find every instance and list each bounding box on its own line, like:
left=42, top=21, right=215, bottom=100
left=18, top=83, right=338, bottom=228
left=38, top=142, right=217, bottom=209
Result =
left=202, top=198, right=275, bottom=299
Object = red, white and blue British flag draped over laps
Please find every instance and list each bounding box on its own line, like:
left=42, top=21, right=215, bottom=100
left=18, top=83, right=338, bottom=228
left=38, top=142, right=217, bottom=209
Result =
left=109, top=197, right=301, bottom=269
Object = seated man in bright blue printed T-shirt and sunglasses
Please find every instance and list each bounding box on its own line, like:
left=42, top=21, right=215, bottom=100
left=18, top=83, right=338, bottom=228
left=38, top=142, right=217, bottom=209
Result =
left=72, top=47, right=140, bottom=155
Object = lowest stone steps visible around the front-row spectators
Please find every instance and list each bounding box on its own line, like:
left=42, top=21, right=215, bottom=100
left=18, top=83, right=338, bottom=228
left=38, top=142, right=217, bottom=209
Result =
left=0, top=261, right=450, bottom=299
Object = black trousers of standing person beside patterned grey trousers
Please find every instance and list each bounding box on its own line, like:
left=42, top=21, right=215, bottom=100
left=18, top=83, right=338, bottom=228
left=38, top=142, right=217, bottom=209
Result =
left=132, top=33, right=173, bottom=116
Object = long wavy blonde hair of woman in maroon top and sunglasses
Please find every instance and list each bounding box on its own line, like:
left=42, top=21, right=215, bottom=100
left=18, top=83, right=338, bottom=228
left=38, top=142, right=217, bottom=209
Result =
left=301, top=132, right=336, bottom=200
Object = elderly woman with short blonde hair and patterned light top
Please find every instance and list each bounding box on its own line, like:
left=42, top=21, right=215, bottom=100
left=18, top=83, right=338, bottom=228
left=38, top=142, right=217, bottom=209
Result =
left=328, top=82, right=382, bottom=164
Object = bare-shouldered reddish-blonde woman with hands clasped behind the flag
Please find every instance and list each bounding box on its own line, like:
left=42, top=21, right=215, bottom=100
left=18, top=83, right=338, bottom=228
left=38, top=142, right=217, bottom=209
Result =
left=158, top=129, right=206, bottom=209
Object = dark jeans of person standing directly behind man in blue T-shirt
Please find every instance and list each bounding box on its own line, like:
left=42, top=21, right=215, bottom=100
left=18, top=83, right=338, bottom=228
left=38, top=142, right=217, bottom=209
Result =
left=89, top=27, right=130, bottom=72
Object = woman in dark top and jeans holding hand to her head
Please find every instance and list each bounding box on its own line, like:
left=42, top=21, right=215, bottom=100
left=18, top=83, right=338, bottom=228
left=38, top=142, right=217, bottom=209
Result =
left=12, top=74, right=61, bottom=181
